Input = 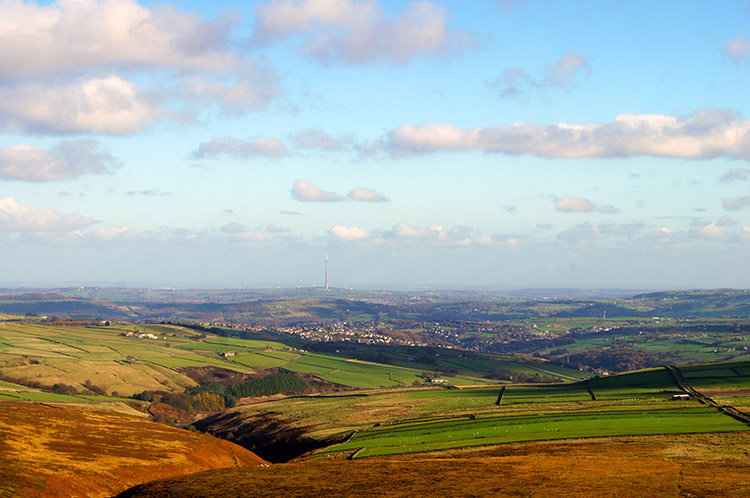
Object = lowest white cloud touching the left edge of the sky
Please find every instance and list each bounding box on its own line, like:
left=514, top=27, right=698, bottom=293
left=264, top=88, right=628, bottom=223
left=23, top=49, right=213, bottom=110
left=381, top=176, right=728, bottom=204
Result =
left=0, top=197, right=94, bottom=234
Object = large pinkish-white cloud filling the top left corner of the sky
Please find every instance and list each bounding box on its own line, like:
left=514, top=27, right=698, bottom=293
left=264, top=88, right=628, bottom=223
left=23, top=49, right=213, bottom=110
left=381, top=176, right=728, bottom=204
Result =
left=0, top=0, right=238, bottom=80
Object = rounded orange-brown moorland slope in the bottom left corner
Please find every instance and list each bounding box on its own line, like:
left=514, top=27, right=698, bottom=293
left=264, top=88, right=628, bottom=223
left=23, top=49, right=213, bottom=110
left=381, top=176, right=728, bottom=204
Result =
left=0, top=402, right=265, bottom=498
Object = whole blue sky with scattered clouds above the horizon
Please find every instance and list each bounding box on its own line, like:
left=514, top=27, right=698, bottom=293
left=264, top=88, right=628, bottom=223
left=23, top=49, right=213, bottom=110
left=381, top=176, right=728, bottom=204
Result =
left=0, top=0, right=750, bottom=289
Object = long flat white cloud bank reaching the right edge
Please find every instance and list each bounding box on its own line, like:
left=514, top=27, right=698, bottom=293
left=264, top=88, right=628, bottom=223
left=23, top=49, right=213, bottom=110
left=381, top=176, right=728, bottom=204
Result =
left=384, top=108, right=750, bottom=159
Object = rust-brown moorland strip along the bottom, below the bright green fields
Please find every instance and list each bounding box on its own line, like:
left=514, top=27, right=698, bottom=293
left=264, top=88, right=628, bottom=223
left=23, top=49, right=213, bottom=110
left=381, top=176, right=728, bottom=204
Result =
left=118, top=433, right=750, bottom=498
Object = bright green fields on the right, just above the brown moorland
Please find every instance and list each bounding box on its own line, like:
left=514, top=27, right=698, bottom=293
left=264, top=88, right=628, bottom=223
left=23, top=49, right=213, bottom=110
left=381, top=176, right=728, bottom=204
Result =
left=310, top=363, right=750, bottom=457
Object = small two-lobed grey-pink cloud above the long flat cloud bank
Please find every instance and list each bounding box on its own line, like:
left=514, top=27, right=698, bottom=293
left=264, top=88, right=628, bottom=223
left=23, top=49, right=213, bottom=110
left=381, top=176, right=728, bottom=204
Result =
left=492, top=51, right=591, bottom=97
